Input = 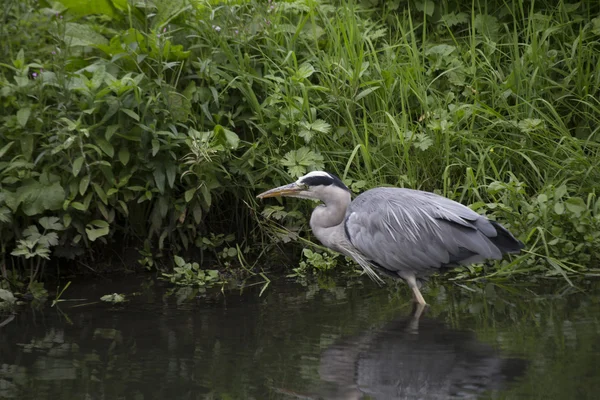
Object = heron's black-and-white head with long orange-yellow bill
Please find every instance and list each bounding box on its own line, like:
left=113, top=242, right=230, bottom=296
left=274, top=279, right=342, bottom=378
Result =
left=257, top=171, right=350, bottom=203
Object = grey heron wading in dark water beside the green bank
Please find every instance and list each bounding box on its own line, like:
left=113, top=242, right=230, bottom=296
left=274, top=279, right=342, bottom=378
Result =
left=257, top=171, right=524, bottom=305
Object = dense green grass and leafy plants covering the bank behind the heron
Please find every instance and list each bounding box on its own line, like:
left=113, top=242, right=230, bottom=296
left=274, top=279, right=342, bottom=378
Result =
left=0, top=0, right=600, bottom=294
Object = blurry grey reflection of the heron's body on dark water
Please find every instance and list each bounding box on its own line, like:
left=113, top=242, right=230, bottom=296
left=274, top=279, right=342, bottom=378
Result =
left=319, top=306, right=526, bottom=400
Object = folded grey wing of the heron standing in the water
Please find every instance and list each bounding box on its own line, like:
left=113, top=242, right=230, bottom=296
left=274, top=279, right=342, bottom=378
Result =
left=345, top=188, right=520, bottom=276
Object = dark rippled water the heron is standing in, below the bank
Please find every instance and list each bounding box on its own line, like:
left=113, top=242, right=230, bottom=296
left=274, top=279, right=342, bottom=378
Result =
left=0, top=277, right=600, bottom=400
